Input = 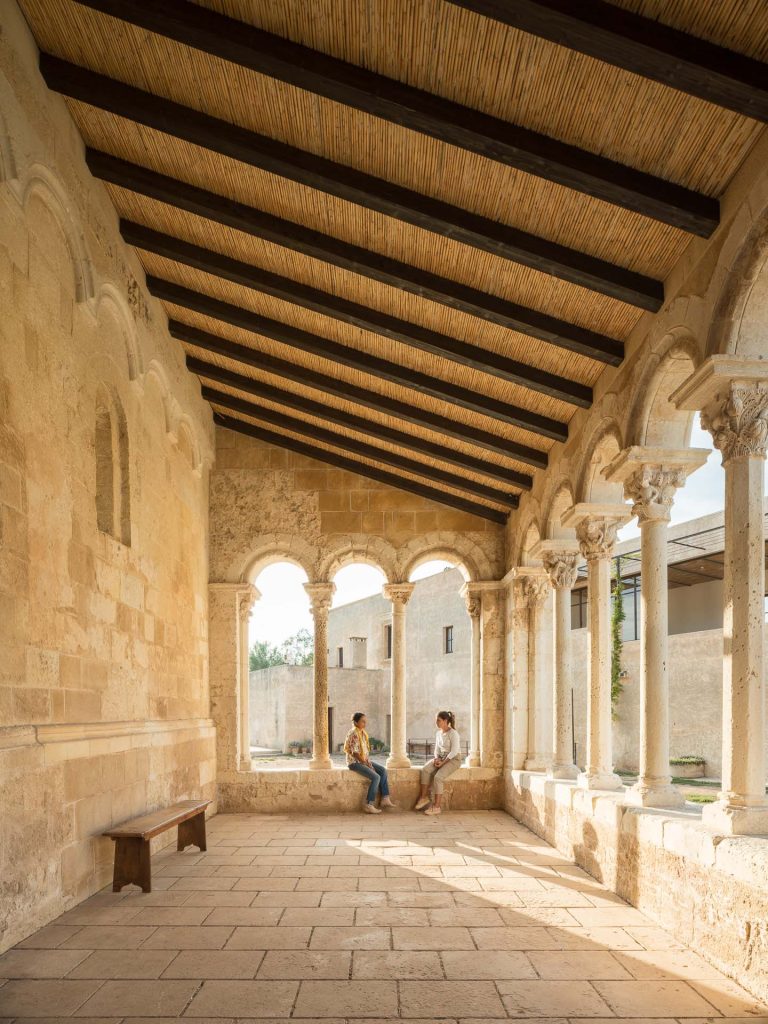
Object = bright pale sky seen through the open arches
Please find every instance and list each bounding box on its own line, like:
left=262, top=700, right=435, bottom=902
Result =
left=250, top=416, right=768, bottom=645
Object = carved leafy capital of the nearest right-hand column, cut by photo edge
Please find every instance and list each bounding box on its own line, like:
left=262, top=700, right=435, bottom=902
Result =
left=701, top=381, right=768, bottom=465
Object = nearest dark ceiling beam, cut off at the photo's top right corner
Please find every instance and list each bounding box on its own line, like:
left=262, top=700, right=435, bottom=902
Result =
left=450, top=0, right=768, bottom=121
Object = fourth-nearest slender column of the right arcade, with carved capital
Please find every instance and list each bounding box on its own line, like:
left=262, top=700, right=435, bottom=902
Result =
left=544, top=549, right=579, bottom=779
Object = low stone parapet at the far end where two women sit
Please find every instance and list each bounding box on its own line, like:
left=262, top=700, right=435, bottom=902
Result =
left=218, top=766, right=503, bottom=814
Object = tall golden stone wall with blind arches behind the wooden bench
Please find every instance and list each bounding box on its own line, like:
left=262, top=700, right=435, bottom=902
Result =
left=0, top=3, right=215, bottom=949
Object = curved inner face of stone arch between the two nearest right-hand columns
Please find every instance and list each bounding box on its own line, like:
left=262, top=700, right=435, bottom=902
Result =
left=627, top=327, right=700, bottom=449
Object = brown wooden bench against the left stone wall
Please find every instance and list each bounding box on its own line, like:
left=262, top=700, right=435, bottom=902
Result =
left=103, top=800, right=211, bottom=893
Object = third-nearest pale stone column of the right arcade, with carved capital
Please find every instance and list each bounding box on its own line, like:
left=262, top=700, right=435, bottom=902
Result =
left=563, top=503, right=631, bottom=790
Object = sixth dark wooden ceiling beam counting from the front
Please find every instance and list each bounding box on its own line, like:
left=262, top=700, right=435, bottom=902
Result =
left=146, top=275, right=568, bottom=441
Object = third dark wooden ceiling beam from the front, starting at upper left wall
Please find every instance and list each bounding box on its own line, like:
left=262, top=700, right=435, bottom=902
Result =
left=40, top=53, right=664, bottom=311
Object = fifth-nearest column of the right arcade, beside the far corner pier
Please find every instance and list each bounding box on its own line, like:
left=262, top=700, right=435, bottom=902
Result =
left=520, top=568, right=552, bottom=771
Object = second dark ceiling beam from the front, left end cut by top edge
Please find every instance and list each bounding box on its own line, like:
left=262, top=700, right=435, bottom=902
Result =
left=70, top=0, right=719, bottom=237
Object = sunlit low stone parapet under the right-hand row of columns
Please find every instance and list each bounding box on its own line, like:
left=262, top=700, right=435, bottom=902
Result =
left=505, top=771, right=768, bottom=999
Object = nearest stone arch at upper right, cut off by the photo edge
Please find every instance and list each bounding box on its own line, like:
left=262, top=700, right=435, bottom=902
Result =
left=707, top=198, right=768, bottom=359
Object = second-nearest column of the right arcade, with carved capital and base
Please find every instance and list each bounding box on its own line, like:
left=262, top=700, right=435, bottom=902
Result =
left=605, top=446, right=709, bottom=807
